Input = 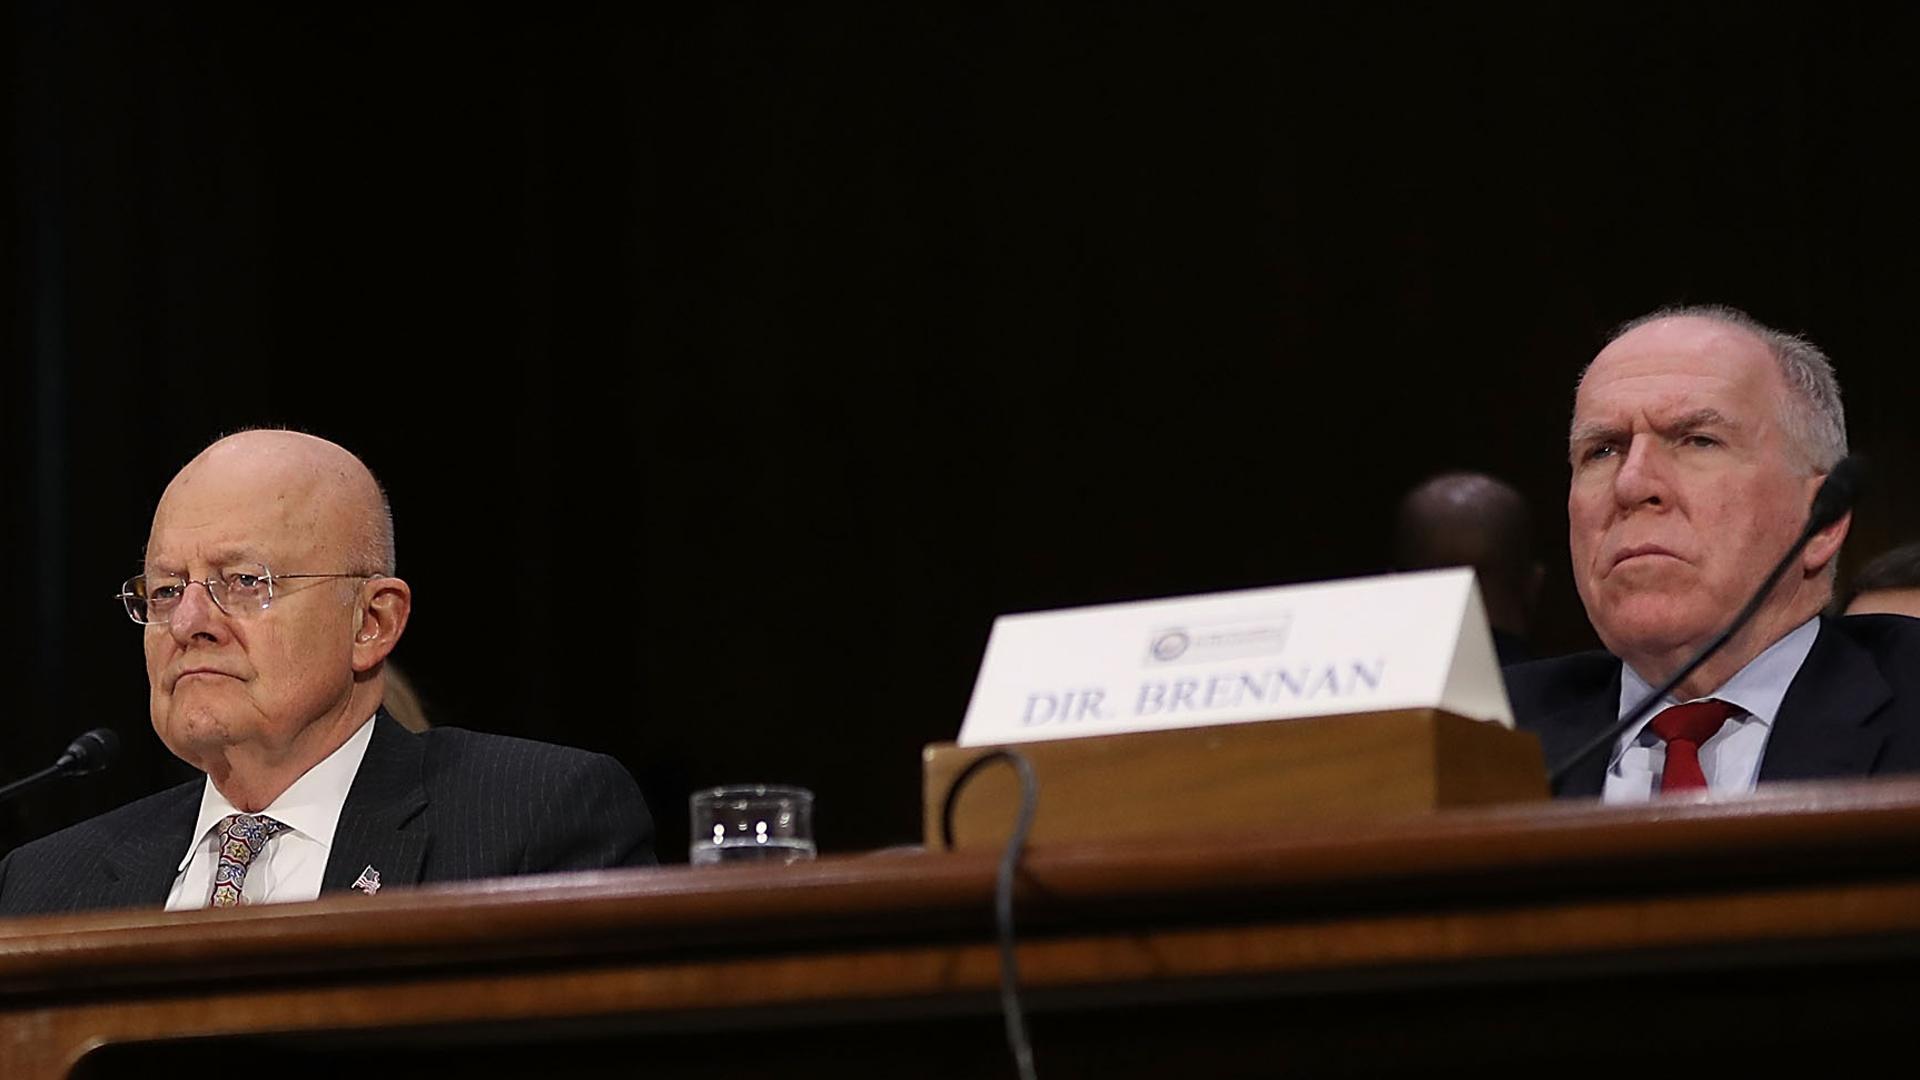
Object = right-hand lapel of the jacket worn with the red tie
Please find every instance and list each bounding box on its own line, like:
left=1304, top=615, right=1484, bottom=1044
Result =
left=1761, top=619, right=1893, bottom=780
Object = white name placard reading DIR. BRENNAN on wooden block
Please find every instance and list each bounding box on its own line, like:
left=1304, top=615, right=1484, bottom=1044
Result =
left=958, top=569, right=1513, bottom=746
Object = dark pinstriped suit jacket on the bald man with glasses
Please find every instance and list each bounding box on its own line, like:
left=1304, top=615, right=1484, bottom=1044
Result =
left=0, top=711, right=653, bottom=917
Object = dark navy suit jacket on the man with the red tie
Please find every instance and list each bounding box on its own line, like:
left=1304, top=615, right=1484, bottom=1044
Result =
left=1505, top=615, right=1920, bottom=796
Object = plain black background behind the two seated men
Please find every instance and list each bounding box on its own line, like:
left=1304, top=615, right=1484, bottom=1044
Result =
left=0, top=0, right=1920, bottom=859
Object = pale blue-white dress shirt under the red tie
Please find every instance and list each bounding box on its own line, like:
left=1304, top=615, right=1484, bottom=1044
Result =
left=1599, top=617, right=1820, bottom=803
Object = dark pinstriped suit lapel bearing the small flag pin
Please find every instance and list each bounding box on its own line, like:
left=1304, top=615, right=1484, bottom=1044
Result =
left=321, top=709, right=428, bottom=894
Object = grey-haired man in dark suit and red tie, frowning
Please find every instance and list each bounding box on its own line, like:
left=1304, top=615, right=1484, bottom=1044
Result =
left=1507, top=306, right=1920, bottom=801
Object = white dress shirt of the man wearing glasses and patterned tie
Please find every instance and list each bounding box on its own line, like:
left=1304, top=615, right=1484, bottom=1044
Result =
left=167, top=717, right=372, bottom=911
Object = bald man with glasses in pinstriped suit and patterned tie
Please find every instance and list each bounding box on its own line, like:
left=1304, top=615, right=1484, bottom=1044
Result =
left=0, top=430, right=653, bottom=917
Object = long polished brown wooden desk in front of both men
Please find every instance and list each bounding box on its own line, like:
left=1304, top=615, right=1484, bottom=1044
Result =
left=0, top=780, right=1920, bottom=1080
